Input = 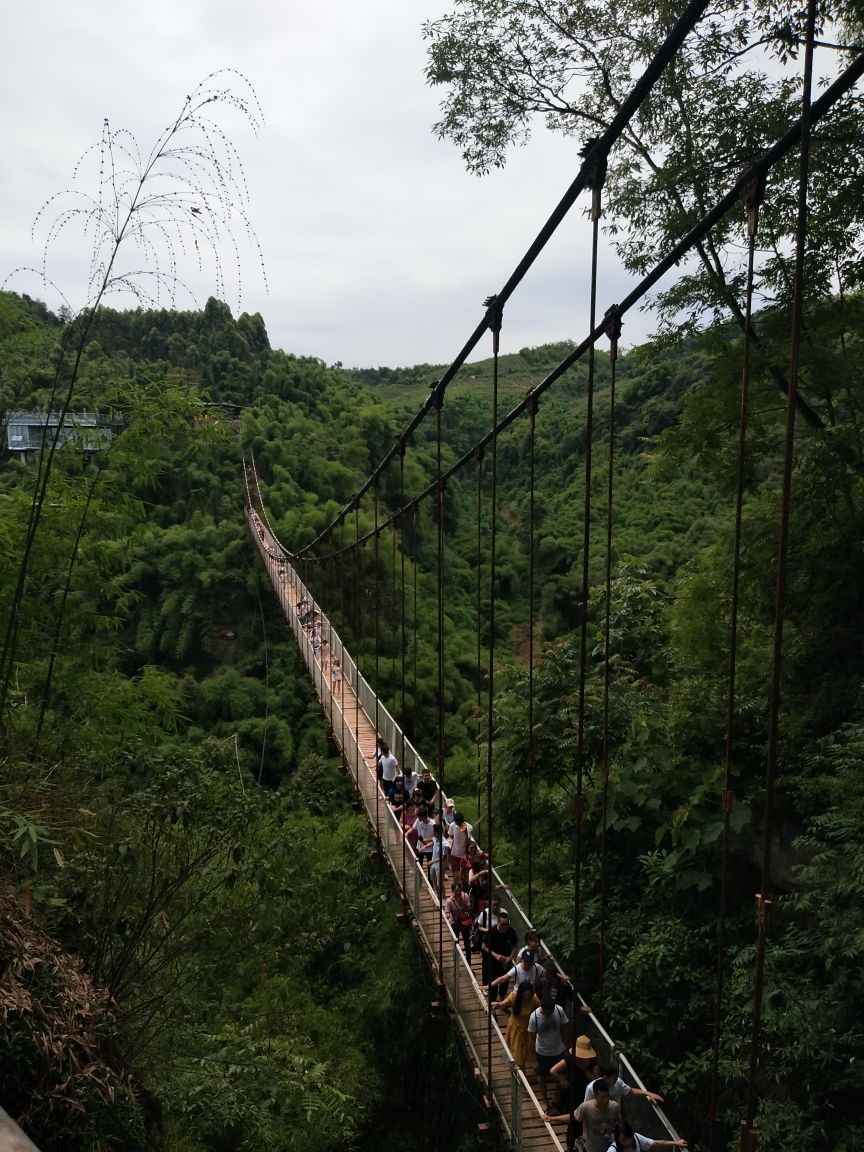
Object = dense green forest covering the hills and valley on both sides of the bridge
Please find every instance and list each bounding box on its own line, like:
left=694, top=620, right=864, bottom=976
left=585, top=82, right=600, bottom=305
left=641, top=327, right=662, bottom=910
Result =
left=0, top=281, right=864, bottom=1152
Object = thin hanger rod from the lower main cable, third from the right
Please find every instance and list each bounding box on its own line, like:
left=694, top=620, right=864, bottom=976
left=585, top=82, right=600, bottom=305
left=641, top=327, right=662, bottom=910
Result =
left=597, top=310, right=621, bottom=1000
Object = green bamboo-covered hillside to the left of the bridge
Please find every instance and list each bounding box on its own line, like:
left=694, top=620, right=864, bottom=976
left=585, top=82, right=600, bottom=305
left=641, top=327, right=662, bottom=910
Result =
left=0, top=294, right=483, bottom=1152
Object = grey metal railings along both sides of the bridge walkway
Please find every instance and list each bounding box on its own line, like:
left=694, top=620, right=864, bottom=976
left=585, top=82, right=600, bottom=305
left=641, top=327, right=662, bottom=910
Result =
left=247, top=508, right=677, bottom=1152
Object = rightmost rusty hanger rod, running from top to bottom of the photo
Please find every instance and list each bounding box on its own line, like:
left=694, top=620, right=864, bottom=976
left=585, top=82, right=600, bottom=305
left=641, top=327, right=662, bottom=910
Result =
left=741, top=0, right=816, bottom=1152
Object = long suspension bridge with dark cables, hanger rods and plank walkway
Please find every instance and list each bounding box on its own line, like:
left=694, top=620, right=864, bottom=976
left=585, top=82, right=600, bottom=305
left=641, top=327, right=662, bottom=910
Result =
left=237, top=0, right=864, bottom=1152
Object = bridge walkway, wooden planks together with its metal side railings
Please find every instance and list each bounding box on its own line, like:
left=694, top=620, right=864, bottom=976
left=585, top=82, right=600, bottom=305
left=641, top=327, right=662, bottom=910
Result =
left=245, top=505, right=677, bottom=1152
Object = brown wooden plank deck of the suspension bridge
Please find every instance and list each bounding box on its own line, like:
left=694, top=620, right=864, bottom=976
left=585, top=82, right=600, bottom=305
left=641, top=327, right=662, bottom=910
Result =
left=247, top=509, right=566, bottom=1152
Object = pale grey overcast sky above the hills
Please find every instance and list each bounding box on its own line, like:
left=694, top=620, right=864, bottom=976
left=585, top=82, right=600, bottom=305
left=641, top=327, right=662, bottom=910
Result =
left=0, top=0, right=651, bottom=366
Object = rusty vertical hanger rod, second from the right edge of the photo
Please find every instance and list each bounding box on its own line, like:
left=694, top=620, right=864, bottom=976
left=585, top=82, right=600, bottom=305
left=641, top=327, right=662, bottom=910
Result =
left=708, top=172, right=765, bottom=1152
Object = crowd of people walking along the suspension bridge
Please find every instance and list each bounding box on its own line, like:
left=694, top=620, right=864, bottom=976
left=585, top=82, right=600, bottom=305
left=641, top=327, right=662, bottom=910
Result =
left=246, top=514, right=685, bottom=1152
